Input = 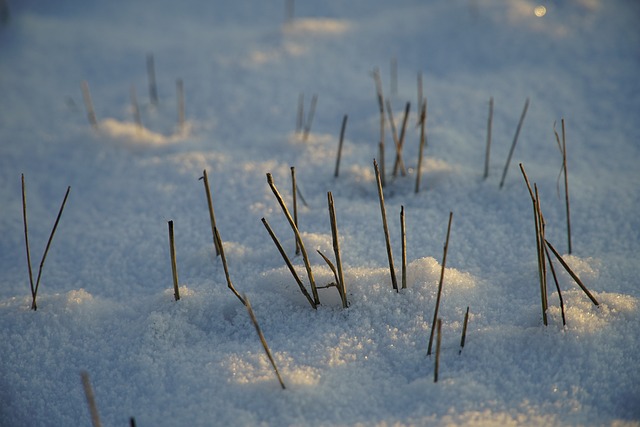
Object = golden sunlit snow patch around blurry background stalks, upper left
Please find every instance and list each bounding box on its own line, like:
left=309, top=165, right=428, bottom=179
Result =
left=98, top=118, right=191, bottom=145
